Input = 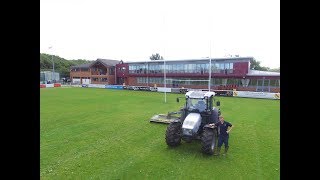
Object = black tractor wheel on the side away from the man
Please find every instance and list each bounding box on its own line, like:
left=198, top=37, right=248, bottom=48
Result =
left=166, top=122, right=182, bottom=146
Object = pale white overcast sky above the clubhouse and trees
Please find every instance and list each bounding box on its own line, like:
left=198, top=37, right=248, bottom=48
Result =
left=40, top=0, right=280, bottom=68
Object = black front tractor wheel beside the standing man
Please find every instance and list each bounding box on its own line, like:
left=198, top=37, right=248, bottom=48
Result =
left=201, top=128, right=218, bottom=155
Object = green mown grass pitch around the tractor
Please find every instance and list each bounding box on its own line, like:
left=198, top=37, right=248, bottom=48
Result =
left=40, top=88, right=280, bottom=179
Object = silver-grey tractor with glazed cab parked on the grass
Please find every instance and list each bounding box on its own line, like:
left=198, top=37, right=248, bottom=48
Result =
left=165, top=91, right=221, bottom=155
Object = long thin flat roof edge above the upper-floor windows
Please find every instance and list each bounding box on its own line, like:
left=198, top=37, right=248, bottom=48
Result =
left=125, top=57, right=254, bottom=64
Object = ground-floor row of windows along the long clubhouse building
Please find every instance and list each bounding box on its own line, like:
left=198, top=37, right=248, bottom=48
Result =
left=137, top=77, right=280, bottom=87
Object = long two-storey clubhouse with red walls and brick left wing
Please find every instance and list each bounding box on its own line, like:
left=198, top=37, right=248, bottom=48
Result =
left=70, top=57, right=280, bottom=92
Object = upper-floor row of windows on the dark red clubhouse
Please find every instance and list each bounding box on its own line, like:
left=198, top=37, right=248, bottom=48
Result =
left=129, top=63, right=233, bottom=74
